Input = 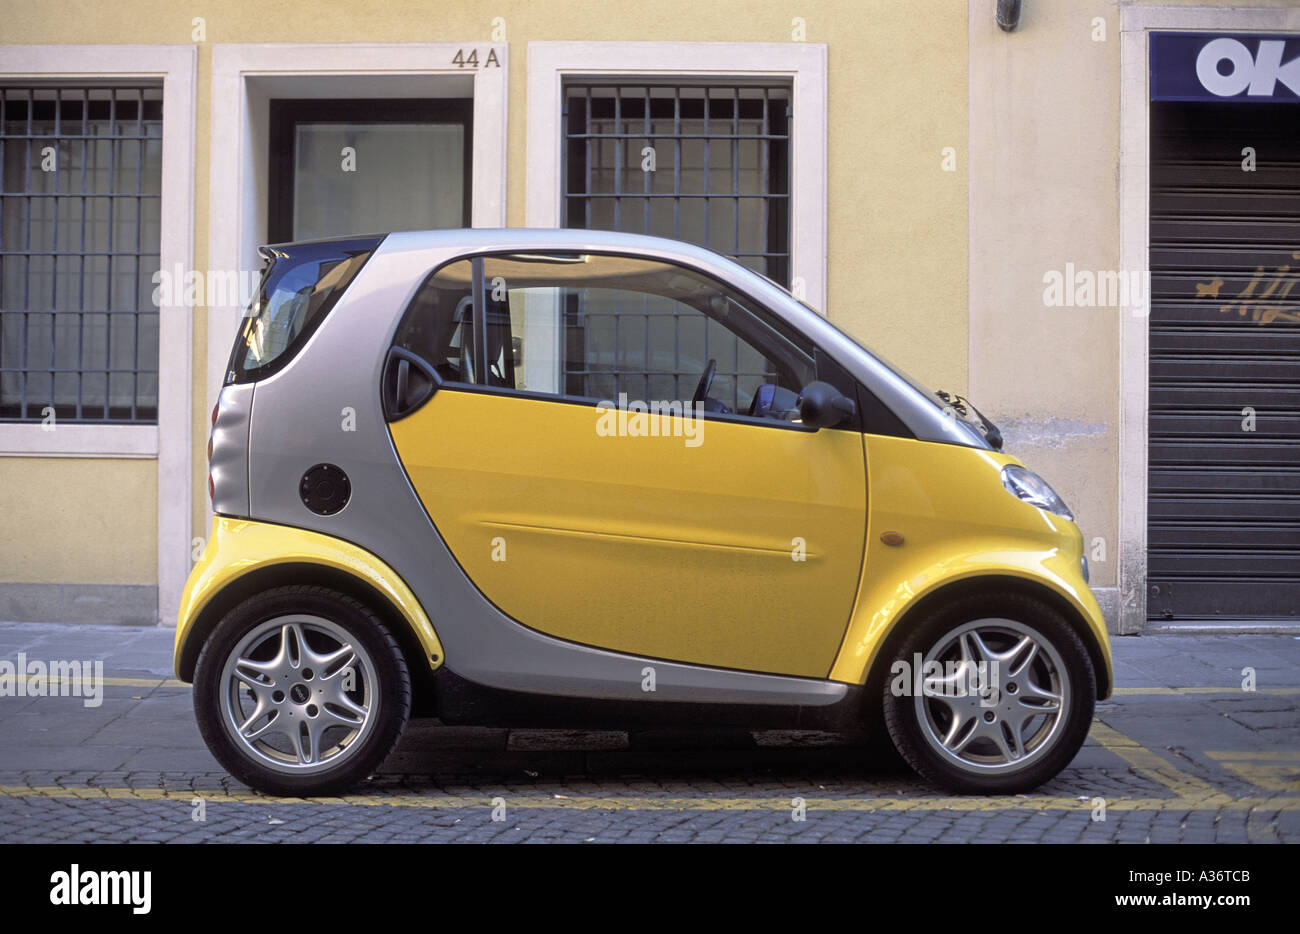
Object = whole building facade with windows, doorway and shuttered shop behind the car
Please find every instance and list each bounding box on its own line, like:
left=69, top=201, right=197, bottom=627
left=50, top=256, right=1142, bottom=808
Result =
left=0, top=0, right=1300, bottom=632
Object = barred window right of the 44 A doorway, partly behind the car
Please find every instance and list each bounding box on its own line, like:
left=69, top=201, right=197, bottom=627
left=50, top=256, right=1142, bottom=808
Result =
left=563, top=79, right=790, bottom=403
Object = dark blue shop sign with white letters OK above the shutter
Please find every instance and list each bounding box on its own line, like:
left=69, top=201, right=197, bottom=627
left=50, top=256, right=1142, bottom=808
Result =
left=1151, top=33, right=1300, bottom=103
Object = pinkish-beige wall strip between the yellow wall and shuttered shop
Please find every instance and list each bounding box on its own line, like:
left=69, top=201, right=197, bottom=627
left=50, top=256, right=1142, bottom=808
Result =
left=969, top=0, right=1295, bottom=602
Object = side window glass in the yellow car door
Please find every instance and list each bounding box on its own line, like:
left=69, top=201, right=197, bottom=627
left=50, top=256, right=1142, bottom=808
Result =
left=398, top=254, right=815, bottom=421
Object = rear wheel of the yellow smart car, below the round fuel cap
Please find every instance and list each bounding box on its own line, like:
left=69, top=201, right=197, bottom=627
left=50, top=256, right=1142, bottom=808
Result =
left=194, top=585, right=411, bottom=795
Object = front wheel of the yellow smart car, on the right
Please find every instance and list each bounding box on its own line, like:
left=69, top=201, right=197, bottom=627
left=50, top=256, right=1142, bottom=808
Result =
left=881, top=594, right=1097, bottom=795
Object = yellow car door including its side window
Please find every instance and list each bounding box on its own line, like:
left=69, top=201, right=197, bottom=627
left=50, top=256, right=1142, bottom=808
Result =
left=386, top=254, right=866, bottom=676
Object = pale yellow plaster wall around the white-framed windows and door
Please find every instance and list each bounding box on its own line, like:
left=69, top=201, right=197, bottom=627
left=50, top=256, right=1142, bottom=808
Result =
left=0, top=0, right=969, bottom=600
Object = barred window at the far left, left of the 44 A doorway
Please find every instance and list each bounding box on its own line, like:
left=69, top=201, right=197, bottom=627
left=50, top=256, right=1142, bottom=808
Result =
left=0, top=85, right=163, bottom=424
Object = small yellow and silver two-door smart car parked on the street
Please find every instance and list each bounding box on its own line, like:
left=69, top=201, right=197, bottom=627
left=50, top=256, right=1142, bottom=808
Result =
left=174, top=229, right=1112, bottom=795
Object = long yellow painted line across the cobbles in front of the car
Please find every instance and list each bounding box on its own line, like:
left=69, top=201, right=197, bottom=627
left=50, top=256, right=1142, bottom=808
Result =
left=0, top=786, right=1300, bottom=813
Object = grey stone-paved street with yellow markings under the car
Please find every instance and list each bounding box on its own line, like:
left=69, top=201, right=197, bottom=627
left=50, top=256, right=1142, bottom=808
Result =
left=0, top=623, right=1300, bottom=843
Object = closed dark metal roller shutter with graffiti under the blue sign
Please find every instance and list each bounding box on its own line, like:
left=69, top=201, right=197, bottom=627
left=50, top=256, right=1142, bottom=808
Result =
left=1147, top=103, right=1300, bottom=622
